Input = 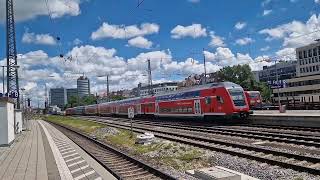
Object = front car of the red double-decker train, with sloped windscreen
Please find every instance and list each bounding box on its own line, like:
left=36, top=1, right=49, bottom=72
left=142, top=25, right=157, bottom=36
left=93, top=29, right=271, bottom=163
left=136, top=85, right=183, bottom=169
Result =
left=155, top=82, right=249, bottom=118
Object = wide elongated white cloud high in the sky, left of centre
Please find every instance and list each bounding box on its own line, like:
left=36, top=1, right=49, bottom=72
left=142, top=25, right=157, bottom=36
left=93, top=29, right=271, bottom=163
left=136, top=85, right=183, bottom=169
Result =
left=91, top=22, right=160, bottom=40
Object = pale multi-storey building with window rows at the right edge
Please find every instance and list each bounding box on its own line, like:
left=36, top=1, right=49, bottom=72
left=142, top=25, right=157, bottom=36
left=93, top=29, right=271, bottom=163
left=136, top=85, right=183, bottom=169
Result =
left=273, top=41, right=320, bottom=103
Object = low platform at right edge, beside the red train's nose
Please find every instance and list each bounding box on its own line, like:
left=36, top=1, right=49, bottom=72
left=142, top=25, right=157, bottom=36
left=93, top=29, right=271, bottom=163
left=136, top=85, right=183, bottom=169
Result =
left=249, top=110, right=320, bottom=128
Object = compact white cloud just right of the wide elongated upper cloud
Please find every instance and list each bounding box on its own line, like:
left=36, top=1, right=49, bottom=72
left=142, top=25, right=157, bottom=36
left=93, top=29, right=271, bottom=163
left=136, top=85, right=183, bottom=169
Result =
left=171, top=24, right=207, bottom=39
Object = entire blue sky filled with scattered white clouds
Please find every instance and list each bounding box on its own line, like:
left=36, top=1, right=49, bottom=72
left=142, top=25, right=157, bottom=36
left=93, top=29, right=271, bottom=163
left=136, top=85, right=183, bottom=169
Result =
left=0, top=0, right=320, bottom=103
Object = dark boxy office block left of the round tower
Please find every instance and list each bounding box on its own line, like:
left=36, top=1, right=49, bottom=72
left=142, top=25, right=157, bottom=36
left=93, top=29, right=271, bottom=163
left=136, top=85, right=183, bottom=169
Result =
left=49, top=88, right=67, bottom=109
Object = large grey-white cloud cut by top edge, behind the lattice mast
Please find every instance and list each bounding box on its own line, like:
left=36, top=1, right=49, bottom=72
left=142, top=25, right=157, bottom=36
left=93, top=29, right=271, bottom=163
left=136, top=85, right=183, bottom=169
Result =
left=0, top=0, right=82, bottom=22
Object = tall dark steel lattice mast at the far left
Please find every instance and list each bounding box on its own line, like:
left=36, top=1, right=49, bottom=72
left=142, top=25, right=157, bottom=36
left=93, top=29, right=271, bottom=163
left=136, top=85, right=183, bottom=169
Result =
left=6, top=0, right=20, bottom=109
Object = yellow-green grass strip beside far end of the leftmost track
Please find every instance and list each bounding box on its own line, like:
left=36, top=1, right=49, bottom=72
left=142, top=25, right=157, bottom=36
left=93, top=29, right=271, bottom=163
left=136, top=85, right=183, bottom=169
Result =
left=44, top=115, right=106, bottom=133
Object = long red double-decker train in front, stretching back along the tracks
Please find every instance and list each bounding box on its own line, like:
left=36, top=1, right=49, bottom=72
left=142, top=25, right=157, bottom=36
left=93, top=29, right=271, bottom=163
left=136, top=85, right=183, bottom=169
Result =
left=66, top=82, right=250, bottom=119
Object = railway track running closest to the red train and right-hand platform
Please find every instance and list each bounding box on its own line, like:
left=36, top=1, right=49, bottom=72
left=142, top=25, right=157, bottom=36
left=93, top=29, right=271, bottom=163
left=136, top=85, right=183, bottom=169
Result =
left=85, top=117, right=320, bottom=148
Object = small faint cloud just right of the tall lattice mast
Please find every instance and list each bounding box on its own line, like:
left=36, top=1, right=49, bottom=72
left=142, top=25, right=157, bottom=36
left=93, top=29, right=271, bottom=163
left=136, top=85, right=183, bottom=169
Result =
left=22, top=31, right=57, bottom=45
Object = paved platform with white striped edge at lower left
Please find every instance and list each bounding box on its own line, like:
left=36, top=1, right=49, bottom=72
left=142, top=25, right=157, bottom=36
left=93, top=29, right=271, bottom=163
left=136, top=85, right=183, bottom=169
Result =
left=0, top=120, right=116, bottom=180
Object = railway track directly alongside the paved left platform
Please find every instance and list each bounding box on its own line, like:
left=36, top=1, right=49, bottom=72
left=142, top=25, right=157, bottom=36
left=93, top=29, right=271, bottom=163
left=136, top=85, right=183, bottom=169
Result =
left=51, top=122, right=175, bottom=180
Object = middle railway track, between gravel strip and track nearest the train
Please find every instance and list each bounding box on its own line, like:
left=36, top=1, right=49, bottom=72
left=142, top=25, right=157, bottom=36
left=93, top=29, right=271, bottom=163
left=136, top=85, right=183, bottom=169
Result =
left=79, top=118, right=320, bottom=175
